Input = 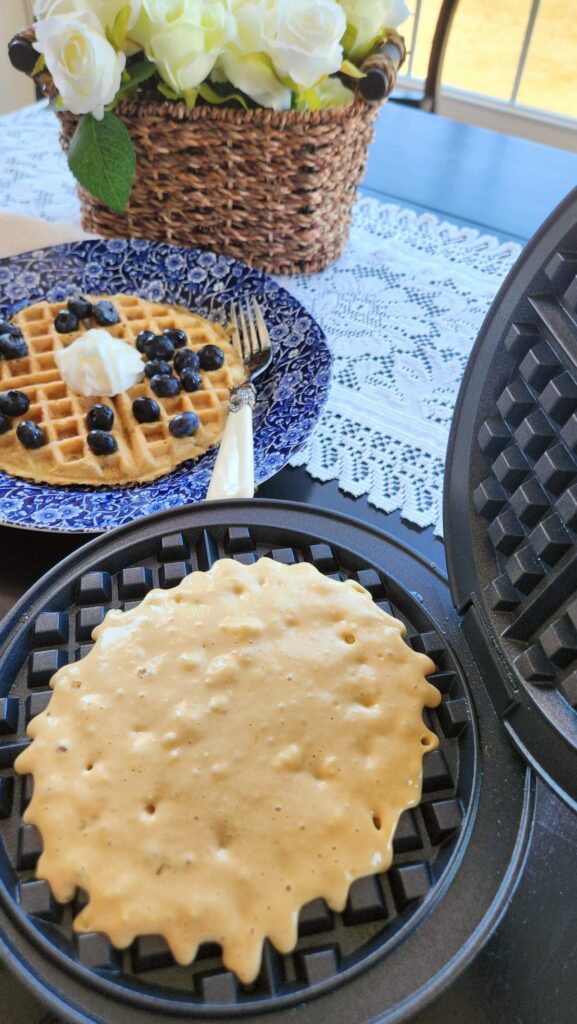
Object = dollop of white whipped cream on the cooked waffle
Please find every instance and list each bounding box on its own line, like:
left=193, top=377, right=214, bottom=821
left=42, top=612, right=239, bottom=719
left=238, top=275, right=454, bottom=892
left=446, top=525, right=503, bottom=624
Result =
left=54, top=328, right=145, bottom=398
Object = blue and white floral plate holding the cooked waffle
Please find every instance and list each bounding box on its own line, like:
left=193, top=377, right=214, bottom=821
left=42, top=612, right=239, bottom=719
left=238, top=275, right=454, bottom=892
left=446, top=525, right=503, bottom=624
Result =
left=0, top=239, right=331, bottom=532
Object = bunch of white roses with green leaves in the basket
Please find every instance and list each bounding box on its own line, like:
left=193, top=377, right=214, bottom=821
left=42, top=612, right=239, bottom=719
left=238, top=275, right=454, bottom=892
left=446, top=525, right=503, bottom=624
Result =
left=34, top=0, right=410, bottom=211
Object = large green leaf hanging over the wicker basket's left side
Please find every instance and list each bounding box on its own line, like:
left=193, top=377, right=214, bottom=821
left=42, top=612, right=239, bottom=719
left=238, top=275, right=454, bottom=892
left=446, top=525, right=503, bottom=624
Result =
left=68, top=112, right=136, bottom=213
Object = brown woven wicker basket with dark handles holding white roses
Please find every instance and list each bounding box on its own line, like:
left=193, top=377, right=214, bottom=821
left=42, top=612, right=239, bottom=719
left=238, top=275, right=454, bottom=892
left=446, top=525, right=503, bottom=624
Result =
left=11, top=32, right=405, bottom=273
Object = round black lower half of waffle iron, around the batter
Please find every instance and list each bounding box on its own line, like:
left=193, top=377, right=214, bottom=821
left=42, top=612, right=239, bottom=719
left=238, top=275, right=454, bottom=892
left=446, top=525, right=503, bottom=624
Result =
left=0, top=501, right=533, bottom=1024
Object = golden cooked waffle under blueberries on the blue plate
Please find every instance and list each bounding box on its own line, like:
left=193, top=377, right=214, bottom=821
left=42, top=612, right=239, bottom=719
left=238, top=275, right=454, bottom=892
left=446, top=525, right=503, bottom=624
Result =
left=0, top=295, right=246, bottom=486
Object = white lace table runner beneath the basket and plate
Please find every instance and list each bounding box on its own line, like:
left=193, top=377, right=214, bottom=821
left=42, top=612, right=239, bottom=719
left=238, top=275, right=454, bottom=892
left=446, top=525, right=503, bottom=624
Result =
left=0, top=103, right=520, bottom=535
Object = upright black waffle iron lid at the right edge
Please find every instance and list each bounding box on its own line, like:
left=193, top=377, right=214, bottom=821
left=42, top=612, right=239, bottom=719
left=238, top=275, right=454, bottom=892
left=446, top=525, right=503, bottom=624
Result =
left=444, top=189, right=577, bottom=808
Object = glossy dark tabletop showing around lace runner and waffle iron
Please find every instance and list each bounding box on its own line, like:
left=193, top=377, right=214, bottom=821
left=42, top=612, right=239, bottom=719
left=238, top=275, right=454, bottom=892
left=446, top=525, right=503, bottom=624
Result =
left=0, top=97, right=577, bottom=1024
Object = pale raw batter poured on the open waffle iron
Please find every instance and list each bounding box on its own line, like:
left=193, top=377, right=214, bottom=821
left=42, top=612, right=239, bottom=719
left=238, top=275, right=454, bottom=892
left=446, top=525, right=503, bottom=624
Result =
left=16, top=558, right=441, bottom=982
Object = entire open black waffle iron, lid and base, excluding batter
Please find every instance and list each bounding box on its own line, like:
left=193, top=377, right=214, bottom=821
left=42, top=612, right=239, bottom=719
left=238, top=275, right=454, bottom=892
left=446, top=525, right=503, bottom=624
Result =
left=0, top=186, right=577, bottom=1024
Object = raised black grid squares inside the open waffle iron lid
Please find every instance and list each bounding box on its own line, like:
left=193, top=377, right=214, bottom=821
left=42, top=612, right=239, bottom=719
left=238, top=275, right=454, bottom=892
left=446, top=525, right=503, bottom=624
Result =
left=472, top=266, right=577, bottom=707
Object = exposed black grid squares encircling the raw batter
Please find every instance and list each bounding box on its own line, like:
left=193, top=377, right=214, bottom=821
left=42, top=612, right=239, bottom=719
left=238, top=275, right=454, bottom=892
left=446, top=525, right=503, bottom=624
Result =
left=0, top=527, right=472, bottom=1011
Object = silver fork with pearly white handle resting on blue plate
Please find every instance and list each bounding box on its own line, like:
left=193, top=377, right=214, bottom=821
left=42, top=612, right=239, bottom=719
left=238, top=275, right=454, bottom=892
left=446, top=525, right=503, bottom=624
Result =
left=206, top=298, right=273, bottom=501
